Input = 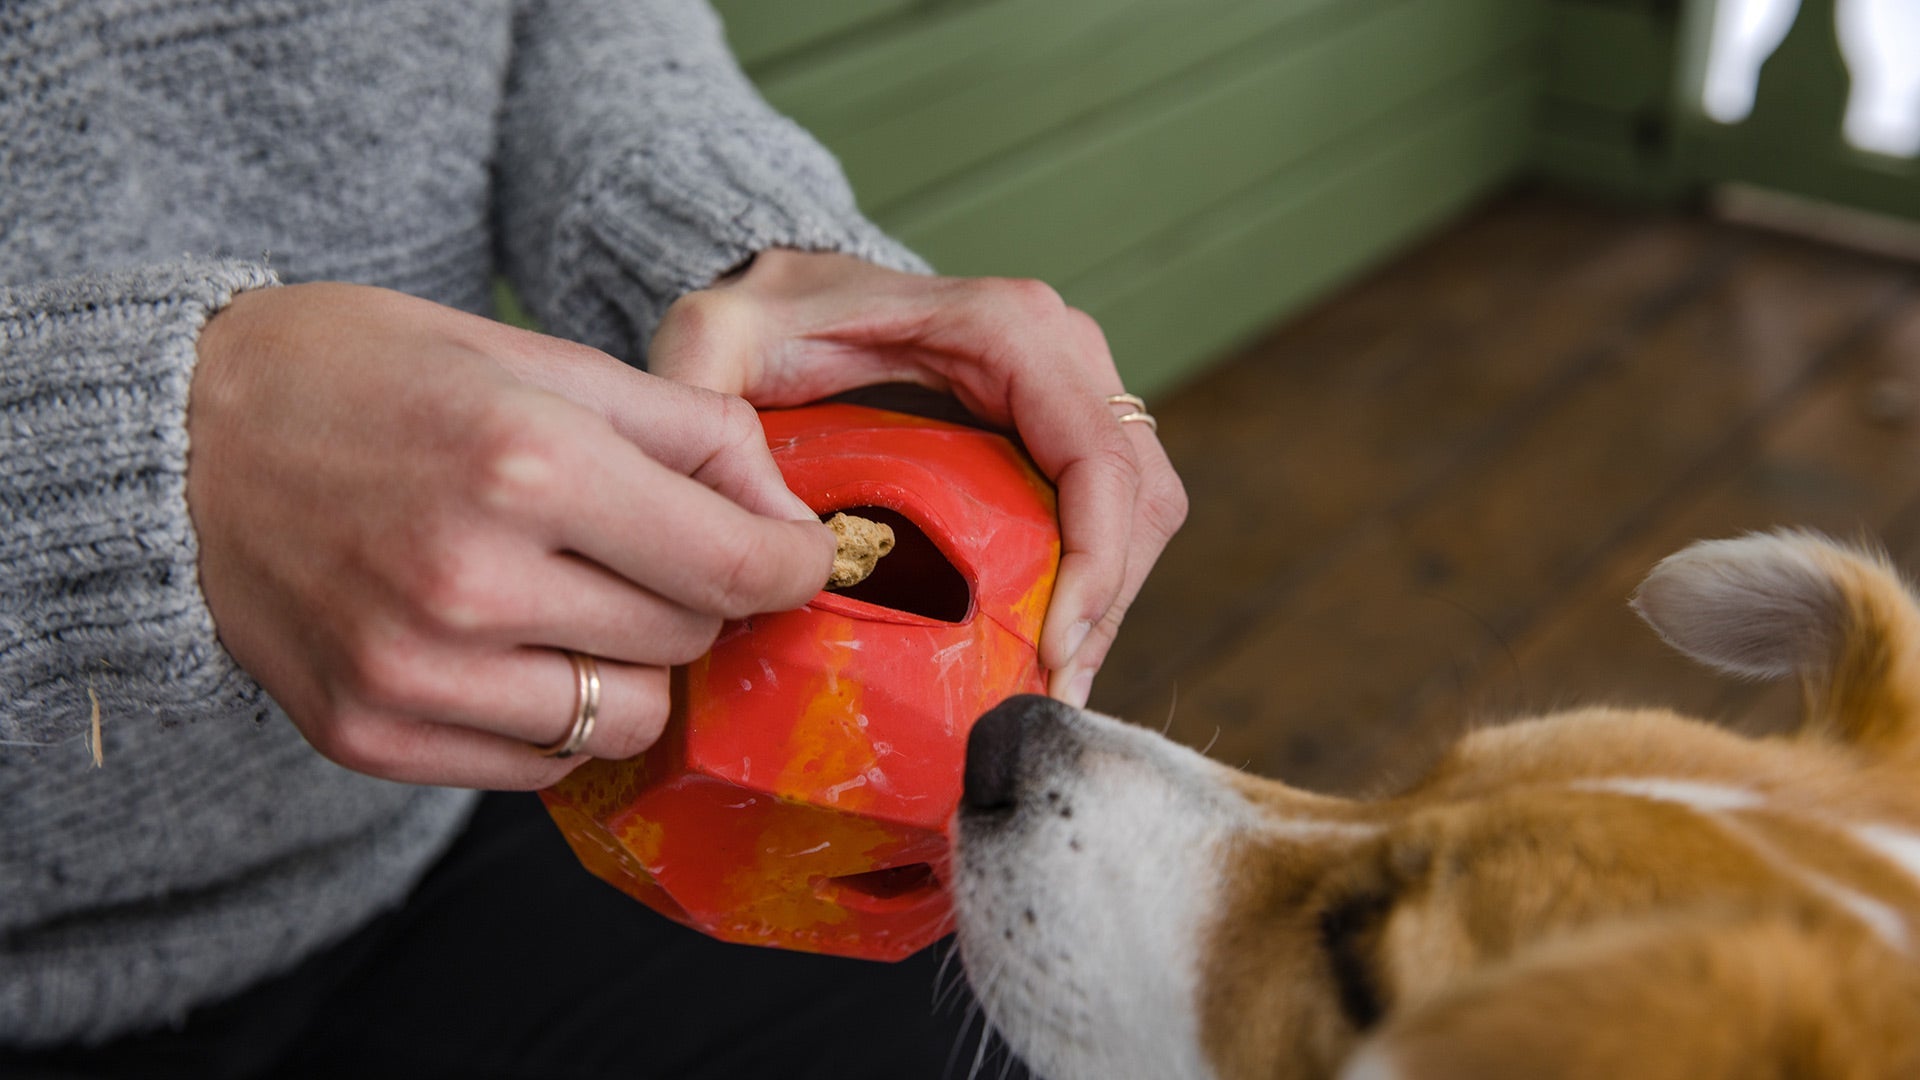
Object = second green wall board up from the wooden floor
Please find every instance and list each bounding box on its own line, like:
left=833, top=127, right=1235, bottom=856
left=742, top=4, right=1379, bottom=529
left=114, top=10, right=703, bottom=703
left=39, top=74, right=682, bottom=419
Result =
left=881, top=0, right=1532, bottom=284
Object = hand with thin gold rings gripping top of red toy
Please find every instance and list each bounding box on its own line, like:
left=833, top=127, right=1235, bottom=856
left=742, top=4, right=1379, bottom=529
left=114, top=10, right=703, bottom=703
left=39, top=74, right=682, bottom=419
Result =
left=647, top=250, right=1187, bottom=705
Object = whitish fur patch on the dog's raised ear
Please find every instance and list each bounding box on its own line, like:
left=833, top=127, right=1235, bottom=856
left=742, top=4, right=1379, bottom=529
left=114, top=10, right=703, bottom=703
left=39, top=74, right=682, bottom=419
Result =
left=1632, top=530, right=1849, bottom=678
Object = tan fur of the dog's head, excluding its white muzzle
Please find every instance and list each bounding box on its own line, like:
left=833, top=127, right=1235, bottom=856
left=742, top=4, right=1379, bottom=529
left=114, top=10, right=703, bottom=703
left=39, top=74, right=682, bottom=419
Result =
left=1200, top=534, right=1920, bottom=1080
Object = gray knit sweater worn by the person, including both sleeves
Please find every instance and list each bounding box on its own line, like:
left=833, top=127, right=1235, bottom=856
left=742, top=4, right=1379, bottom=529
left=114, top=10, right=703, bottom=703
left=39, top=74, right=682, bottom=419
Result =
left=0, top=0, right=918, bottom=1045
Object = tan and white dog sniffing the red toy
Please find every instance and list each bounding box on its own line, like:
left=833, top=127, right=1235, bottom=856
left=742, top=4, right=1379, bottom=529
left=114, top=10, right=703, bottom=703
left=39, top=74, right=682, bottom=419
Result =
left=950, top=532, right=1920, bottom=1080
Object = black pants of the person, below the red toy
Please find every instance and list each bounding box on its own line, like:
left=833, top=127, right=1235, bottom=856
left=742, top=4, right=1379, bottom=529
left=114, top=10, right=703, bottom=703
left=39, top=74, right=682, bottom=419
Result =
left=0, top=794, right=1025, bottom=1080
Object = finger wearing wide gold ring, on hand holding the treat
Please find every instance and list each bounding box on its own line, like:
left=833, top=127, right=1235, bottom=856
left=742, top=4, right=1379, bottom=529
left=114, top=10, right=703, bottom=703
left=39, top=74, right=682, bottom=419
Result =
left=345, top=648, right=670, bottom=757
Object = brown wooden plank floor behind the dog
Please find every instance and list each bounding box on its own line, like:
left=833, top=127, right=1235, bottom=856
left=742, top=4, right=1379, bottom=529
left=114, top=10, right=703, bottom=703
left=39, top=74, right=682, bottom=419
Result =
left=1092, top=182, right=1920, bottom=792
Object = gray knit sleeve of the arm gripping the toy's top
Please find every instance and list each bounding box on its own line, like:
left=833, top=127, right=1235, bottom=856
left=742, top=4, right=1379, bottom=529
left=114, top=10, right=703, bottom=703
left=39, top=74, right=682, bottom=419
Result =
left=495, top=0, right=925, bottom=363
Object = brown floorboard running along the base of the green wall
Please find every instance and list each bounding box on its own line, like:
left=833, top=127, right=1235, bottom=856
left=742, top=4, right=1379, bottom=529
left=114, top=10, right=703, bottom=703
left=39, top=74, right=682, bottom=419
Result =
left=1100, top=187, right=1716, bottom=713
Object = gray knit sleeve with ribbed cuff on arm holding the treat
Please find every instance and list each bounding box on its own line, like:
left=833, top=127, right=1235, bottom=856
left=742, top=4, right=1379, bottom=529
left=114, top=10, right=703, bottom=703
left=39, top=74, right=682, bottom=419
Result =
left=0, top=259, right=273, bottom=746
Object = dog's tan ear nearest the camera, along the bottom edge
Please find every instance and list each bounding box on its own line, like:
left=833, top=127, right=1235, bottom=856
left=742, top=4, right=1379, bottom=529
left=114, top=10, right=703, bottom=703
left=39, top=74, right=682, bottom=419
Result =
left=1340, top=907, right=1920, bottom=1080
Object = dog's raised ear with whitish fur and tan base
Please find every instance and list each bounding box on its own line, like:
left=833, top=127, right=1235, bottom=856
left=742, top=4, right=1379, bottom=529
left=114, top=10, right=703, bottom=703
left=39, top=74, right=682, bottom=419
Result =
left=1634, top=532, right=1920, bottom=749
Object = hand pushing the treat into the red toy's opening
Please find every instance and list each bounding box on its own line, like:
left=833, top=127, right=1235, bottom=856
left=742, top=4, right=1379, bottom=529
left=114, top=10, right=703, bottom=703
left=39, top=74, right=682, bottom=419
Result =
left=186, top=284, right=833, bottom=788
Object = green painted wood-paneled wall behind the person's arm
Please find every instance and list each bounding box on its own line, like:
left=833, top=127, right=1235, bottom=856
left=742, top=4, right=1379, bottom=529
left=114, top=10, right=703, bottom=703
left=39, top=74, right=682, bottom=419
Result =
left=716, top=0, right=1546, bottom=394
